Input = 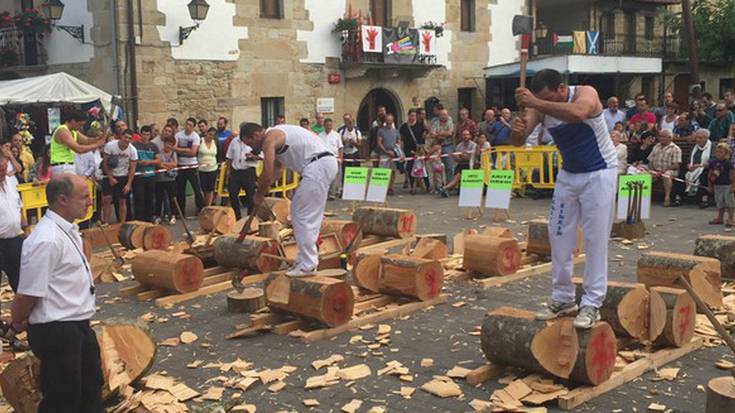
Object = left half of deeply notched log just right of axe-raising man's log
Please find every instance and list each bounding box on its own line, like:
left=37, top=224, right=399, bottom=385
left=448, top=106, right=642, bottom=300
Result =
left=573, top=278, right=662, bottom=340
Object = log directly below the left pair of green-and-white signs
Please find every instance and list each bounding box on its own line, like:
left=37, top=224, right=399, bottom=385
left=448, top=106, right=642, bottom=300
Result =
left=352, top=207, right=416, bottom=238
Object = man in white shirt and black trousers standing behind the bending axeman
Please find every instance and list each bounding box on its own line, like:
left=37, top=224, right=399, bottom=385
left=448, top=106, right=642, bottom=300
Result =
left=226, top=136, right=260, bottom=219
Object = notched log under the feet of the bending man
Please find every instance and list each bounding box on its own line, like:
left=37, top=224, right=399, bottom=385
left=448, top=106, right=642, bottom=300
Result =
left=265, top=274, right=355, bottom=327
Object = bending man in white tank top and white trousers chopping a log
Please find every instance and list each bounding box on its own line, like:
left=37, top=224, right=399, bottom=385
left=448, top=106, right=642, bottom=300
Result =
left=240, top=123, right=338, bottom=277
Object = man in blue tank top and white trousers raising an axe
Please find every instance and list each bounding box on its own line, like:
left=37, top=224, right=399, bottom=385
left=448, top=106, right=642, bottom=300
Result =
left=511, top=69, right=617, bottom=328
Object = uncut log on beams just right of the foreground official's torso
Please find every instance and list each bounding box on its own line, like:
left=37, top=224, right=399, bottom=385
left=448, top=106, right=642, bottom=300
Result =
left=131, top=250, right=204, bottom=293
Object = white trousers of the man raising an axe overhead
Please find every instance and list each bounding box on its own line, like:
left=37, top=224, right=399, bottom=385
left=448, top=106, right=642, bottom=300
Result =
left=549, top=168, right=618, bottom=308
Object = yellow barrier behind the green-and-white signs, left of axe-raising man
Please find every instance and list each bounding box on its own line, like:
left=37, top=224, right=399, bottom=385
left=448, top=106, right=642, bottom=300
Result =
left=480, top=145, right=562, bottom=189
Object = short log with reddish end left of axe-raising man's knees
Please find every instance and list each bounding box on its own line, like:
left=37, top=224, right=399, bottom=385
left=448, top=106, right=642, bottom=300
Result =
left=462, top=235, right=521, bottom=277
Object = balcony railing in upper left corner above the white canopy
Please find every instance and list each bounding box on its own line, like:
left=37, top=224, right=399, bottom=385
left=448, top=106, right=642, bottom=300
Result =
left=0, top=27, right=46, bottom=67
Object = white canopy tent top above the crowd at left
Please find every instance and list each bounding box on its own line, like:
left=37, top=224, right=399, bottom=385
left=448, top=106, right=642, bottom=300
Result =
left=0, top=72, right=112, bottom=113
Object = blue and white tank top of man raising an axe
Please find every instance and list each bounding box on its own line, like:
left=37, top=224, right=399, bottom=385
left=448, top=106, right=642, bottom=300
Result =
left=543, top=86, right=618, bottom=173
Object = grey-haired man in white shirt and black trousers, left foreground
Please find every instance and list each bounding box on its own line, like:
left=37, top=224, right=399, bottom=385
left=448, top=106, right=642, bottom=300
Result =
left=11, top=174, right=104, bottom=413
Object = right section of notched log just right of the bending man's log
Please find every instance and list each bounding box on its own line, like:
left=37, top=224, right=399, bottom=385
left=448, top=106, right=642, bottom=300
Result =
left=374, top=254, right=444, bottom=301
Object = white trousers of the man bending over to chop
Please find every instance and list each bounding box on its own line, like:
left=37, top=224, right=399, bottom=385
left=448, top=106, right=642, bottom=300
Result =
left=291, top=156, right=338, bottom=270
